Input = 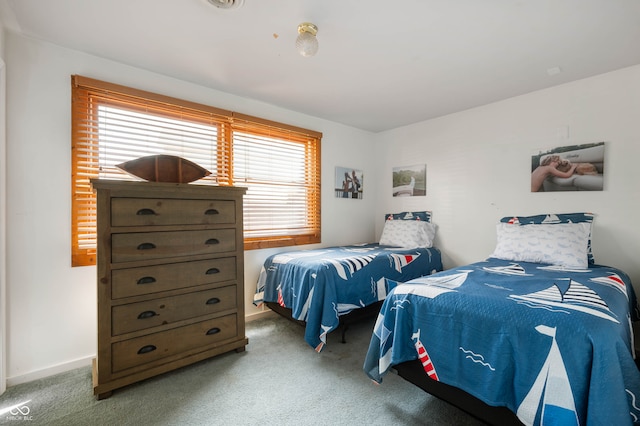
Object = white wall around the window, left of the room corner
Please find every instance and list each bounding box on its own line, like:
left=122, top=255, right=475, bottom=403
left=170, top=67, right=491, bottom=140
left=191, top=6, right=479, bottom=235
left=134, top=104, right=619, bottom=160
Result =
left=6, top=33, right=375, bottom=385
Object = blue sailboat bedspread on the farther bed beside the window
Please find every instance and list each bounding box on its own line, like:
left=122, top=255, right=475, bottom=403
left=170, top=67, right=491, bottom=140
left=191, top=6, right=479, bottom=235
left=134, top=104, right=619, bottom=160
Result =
left=254, top=243, right=442, bottom=352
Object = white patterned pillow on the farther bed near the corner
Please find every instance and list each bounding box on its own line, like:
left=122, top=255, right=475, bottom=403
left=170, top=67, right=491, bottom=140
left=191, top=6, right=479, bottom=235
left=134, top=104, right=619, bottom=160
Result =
left=380, top=220, right=436, bottom=248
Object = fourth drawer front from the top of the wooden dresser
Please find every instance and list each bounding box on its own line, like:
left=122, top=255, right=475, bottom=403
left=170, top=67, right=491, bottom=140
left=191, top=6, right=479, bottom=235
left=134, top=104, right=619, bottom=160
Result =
left=111, top=285, right=236, bottom=336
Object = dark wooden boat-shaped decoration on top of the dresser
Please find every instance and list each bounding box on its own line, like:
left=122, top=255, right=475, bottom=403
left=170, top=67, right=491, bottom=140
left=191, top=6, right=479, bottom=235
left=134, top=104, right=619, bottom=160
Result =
left=116, top=154, right=211, bottom=183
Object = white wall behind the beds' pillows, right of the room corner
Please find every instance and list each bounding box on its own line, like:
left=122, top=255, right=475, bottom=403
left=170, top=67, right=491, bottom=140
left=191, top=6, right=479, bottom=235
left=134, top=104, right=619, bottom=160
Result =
left=376, top=66, right=640, bottom=289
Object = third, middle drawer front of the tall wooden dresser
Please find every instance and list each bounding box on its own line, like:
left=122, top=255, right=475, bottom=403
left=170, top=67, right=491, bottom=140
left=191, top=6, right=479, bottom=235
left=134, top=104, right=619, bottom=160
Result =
left=111, top=256, right=237, bottom=299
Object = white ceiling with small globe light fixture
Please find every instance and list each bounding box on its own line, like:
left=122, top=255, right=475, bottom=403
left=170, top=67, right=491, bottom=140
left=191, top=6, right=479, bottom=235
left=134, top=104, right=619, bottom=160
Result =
left=0, top=0, right=640, bottom=132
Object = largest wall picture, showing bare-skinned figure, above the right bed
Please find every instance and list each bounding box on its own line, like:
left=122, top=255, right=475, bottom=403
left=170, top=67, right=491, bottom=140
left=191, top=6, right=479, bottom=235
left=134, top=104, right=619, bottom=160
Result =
left=531, top=142, right=605, bottom=192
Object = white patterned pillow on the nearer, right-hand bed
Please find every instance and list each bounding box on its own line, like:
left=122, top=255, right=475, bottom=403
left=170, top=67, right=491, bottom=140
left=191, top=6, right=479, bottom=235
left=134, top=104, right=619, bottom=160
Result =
left=491, top=222, right=591, bottom=269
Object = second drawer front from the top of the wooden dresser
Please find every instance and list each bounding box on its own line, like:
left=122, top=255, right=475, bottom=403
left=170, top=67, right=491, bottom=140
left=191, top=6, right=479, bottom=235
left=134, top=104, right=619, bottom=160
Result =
left=111, top=229, right=236, bottom=263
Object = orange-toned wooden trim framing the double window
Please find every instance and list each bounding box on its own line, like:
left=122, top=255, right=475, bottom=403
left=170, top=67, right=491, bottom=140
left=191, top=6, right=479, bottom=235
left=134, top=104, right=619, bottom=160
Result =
left=71, top=75, right=322, bottom=266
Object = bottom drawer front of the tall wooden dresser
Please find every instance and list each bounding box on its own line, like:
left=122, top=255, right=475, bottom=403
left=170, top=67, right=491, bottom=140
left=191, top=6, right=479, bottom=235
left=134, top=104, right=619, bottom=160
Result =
left=111, top=314, right=237, bottom=373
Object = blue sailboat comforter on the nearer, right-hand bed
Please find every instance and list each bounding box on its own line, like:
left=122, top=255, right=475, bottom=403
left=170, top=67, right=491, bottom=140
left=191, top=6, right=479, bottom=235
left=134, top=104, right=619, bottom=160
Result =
left=364, top=258, right=640, bottom=425
